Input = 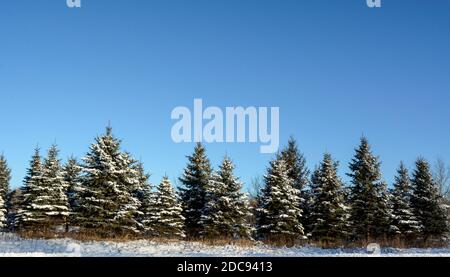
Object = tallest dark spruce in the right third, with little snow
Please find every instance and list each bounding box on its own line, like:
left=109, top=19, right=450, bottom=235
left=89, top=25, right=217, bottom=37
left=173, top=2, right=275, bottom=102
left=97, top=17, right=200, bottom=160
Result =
left=348, top=137, right=390, bottom=239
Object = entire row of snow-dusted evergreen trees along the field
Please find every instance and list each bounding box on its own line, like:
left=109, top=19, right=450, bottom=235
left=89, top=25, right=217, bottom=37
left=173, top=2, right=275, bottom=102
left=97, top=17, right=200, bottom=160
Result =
left=0, top=127, right=448, bottom=245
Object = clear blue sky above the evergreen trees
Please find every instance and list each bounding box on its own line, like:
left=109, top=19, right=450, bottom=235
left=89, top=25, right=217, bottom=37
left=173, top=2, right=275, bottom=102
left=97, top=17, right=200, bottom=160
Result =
left=0, top=0, right=450, bottom=187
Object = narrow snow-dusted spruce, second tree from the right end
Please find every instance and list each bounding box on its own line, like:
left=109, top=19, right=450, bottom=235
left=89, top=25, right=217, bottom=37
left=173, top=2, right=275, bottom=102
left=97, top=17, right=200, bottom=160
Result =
left=391, top=162, right=420, bottom=239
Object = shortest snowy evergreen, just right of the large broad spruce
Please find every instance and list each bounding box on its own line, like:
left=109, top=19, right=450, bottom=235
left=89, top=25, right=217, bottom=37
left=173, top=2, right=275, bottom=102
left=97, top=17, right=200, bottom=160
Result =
left=150, top=177, right=185, bottom=239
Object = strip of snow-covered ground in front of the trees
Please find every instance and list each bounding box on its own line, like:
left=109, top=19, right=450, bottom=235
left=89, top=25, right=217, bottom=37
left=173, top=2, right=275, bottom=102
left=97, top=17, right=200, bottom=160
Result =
left=0, top=231, right=450, bottom=257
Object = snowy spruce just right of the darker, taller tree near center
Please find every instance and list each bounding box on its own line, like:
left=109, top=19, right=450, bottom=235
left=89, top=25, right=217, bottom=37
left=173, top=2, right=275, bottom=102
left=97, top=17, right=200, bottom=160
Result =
left=202, top=157, right=252, bottom=239
